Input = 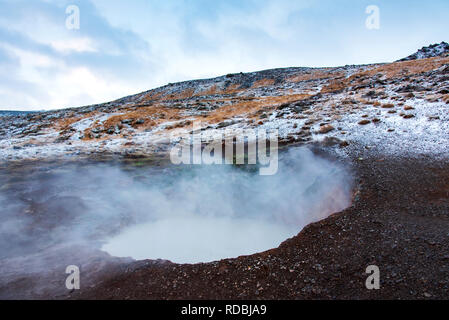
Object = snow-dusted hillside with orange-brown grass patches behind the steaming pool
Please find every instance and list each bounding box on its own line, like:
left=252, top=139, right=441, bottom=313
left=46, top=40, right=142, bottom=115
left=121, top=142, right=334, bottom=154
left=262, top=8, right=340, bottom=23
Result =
left=0, top=43, right=449, bottom=161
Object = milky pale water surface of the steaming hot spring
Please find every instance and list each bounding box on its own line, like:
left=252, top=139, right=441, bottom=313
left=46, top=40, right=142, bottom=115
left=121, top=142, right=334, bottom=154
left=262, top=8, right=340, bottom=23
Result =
left=103, top=216, right=297, bottom=263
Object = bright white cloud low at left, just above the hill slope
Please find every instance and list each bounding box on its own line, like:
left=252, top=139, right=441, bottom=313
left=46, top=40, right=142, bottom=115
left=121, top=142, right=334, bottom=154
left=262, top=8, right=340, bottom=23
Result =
left=0, top=45, right=135, bottom=109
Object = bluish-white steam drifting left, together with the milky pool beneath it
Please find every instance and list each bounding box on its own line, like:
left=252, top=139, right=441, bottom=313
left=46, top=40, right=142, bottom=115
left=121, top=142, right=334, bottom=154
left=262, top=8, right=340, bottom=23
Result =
left=0, top=148, right=351, bottom=296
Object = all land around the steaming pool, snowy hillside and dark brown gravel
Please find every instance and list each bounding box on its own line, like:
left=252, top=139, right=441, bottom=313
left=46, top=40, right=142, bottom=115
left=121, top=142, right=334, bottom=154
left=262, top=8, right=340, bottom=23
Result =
left=0, top=43, right=449, bottom=299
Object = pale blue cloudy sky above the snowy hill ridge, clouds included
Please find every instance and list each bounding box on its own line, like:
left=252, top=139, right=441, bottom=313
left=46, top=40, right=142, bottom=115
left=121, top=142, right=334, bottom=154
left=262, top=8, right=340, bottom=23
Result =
left=0, top=0, right=449, bottom=110
